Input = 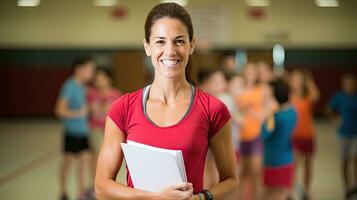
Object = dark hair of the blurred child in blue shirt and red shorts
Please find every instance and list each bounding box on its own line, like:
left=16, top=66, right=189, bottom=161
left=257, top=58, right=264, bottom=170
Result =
left=269, top=79, right=290, bottom=104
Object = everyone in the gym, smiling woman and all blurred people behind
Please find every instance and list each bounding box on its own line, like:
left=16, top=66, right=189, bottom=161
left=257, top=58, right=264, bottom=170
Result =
left=52, top=3, right=357, bottom=200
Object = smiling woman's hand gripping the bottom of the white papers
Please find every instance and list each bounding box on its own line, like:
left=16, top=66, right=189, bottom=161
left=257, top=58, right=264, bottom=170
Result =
left=158, top=183, right=193, bottom=200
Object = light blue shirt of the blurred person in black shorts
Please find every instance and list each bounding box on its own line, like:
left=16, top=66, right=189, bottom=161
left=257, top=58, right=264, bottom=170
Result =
left=60, top=78, right=89, bottom=137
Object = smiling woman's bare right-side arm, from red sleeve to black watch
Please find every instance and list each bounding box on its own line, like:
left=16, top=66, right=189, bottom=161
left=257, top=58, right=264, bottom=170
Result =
left=206, top=121, right=239, bottom=200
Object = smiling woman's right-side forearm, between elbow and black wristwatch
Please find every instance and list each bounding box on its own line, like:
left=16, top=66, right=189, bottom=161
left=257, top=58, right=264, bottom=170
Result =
left=209, top=176, right=239, bottom=200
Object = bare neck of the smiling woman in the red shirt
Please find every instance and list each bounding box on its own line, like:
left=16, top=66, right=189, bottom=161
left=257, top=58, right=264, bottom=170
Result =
left=149, top=74, right=190, bottom=103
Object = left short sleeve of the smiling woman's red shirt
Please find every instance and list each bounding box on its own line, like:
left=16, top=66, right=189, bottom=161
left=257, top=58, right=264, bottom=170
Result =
left=108, top=94, right=129, bottom=134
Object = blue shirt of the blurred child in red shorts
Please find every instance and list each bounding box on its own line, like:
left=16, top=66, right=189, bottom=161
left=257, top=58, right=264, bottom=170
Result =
left=262, top=106, right=297, bottom=167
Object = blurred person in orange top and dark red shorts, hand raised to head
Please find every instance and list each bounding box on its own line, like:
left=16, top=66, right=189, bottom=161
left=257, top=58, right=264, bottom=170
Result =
left=289, top=69, right=320, bottom=200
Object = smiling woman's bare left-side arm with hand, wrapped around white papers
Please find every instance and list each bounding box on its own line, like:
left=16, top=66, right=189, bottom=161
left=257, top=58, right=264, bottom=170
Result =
left=95, top=117, right=193, bottom=200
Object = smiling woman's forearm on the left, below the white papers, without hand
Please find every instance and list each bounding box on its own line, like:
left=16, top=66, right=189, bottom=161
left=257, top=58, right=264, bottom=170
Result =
left=95, top=179, right=159, bottom=200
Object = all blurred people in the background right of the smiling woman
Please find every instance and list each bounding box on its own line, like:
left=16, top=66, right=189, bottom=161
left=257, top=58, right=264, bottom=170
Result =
left=198, top=62, right=357, bottom=199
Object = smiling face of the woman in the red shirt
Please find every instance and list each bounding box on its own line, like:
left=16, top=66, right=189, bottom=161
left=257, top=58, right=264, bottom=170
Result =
left=144, top=17, right=194, bottom=79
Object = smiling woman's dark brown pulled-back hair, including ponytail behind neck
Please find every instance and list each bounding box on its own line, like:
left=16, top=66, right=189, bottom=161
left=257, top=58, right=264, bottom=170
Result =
left=145, top=3, right=196, bottom=85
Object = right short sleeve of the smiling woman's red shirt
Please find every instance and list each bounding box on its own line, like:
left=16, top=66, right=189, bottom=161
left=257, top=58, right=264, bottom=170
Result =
left=208, top=96, right=231, bottom=138
